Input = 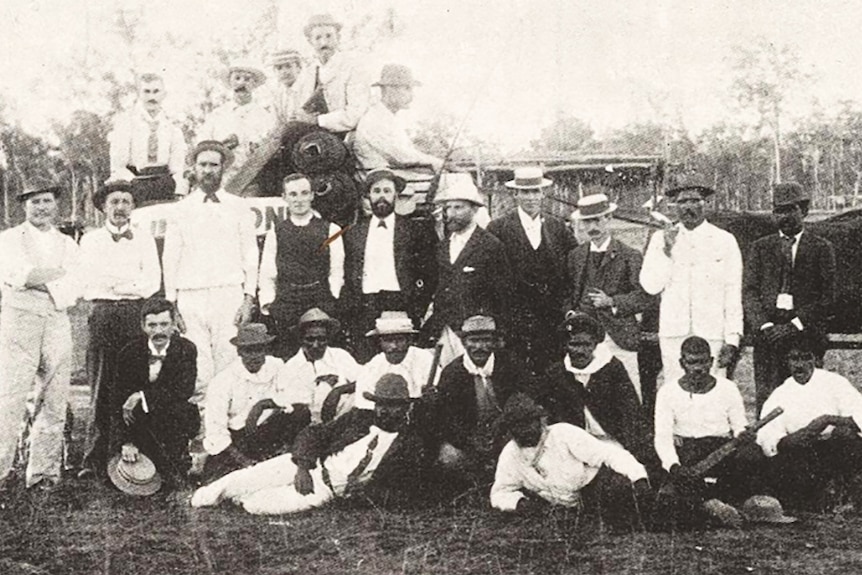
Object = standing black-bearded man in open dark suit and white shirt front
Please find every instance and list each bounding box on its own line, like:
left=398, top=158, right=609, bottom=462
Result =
left=340, top=169, right=437, bottom=363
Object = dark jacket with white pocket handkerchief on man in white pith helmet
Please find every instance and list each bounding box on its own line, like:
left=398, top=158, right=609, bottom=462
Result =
left=431, top=227, right=512, bottom=336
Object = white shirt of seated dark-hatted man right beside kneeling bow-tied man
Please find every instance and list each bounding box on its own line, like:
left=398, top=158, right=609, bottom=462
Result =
left=204, top=356, right=284, bottom=455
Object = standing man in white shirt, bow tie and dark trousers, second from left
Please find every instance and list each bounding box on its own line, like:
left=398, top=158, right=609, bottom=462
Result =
left=81, top=181, right=162, bottom=477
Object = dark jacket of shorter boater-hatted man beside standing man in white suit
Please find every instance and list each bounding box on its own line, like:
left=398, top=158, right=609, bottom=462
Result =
left=566, top=238, right=655, bottom=351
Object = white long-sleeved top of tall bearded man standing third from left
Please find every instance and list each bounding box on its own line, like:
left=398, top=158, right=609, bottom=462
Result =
left=162, top=189, right=258, bottom=301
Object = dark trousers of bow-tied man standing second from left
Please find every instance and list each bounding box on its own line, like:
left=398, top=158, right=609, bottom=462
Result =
left=82, top=299, right=144, bottom=475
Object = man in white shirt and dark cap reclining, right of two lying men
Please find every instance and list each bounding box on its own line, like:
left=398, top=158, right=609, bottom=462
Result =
left=491, top=393, right=652, bottom=528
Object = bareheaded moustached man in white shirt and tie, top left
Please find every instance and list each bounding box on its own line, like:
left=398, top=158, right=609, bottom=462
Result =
left=108, top=72, right=188, bottom=195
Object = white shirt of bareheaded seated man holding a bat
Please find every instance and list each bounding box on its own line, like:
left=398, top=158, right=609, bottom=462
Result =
left=655, top=376, right=748, bottom=470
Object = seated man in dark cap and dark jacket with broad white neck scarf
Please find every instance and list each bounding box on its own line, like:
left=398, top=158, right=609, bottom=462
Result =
left=540, top=311, right=660, bottom=480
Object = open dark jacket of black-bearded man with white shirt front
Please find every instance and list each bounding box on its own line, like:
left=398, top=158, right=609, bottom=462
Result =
left=342, top=214, right=437, bottom=317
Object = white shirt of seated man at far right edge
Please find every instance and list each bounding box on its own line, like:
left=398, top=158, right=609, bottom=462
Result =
left=757, top=369, right=862, bottom=457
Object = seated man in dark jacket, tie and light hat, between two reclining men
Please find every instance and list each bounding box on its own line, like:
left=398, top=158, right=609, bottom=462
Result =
left=435, top=316, right=528, bottom=479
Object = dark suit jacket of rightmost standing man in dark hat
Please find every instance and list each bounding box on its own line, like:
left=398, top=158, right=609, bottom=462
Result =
left=742, top=231, right=836, bottom=333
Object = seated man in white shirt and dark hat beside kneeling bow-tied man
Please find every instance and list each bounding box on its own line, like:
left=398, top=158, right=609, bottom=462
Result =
left=204, top=323, right=310, bottom=481
